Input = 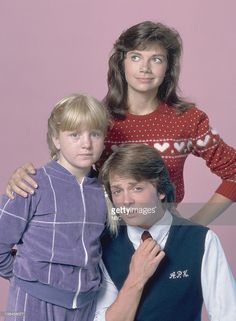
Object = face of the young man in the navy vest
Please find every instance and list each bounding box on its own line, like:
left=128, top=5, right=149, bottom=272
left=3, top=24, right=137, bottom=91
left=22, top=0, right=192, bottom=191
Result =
left=109, top=174, right=165, bottom=229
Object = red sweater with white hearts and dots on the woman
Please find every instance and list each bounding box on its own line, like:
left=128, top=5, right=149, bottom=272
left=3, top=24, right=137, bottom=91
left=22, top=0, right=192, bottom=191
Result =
left=99, top=103, right=236, bottom=203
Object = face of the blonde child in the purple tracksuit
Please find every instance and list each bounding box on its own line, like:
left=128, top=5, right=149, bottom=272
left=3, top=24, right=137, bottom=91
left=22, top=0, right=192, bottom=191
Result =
left=53, top=129, right=104, bottom=180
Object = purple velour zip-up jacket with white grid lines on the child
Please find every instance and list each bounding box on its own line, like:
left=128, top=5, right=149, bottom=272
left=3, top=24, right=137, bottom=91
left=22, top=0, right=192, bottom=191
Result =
left=0, top=161, right=107, bottom=308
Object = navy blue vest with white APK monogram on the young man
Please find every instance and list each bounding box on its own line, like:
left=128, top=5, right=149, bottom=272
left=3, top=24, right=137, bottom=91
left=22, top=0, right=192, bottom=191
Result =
left=102, top=216, right=208, bottom=321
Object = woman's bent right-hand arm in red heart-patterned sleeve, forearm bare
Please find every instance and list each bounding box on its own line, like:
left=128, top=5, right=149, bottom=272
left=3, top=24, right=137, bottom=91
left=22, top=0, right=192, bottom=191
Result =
left=188, top=110, right=236, bottom=225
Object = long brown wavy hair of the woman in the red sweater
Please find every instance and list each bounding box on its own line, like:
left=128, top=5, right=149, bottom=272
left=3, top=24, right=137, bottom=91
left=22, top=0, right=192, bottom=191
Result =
left=103, top=21, right=195, bottom=117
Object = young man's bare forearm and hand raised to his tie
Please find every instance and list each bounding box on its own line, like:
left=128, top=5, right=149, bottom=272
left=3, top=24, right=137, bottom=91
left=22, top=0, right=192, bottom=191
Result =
left=95, top=239, right=165, bottom=321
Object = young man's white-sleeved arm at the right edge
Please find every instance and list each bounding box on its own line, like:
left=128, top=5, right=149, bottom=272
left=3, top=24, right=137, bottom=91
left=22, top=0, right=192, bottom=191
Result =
left=201, top=231, right=236, bottom=321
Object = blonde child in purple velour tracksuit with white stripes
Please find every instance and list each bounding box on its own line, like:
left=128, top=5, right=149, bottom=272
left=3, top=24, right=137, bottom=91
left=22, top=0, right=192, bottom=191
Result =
left=0, top=94, right=108, bottom=321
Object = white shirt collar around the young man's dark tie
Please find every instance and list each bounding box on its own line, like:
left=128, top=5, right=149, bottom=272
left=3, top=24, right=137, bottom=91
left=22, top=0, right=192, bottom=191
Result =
left=127, top=210, right=173, bottom=248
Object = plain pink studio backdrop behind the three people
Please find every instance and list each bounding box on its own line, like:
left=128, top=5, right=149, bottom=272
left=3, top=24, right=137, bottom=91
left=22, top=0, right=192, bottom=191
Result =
left=0, top=0, right=236, bottom=320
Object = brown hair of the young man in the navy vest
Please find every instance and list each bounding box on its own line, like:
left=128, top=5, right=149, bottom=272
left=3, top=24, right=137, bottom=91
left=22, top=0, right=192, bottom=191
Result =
left=99, top=143, right=175, bottom=234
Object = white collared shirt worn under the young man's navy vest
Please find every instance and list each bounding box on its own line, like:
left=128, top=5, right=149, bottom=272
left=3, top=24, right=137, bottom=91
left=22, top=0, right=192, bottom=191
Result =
left=94, top=211, right=236, bottom=321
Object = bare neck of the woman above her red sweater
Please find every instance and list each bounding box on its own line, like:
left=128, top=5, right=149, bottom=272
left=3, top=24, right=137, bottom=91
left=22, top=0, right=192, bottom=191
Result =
left=128, top=93, right=159, bottom=115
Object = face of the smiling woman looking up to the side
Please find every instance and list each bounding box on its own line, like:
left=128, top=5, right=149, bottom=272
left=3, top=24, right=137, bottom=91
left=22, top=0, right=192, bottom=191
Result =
left=124, top=44, right=167, bottom=96
